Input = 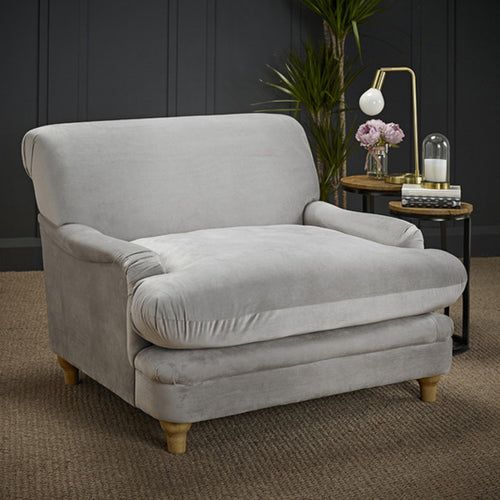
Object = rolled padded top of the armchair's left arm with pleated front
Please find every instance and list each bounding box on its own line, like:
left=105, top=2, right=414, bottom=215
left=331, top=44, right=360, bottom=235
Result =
left=39, top=215, right=165, bottom=293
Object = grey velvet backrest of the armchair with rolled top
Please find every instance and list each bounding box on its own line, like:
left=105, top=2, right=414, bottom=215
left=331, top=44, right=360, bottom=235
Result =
left=22, top=113, right=318, bottom=240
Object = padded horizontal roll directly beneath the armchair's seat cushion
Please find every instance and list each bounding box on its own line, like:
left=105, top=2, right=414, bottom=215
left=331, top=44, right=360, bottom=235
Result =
left=134, top=313, right=453, bottom=385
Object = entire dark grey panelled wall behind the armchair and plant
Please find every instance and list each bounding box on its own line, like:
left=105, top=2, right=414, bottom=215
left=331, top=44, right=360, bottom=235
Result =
left=0, top=0, right=500, bottom=270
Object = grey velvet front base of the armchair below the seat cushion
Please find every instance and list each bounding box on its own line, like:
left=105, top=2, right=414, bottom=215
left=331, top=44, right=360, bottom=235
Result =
left=136, top=315, right=452, bottom=422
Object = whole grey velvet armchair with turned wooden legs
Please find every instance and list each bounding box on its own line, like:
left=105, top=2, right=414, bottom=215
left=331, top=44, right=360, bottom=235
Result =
left=22, top=114, right=466, bottom=453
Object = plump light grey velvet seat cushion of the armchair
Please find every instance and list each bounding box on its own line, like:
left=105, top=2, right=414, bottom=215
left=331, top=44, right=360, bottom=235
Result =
left=130, top=225, right=466, bottom=348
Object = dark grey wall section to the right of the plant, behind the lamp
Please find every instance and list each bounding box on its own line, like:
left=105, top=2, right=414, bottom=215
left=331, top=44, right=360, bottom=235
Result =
left=350, top=0, right=500, bottom=256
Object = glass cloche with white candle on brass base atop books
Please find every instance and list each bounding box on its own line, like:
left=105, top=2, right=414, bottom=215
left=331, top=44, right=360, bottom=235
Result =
left=422, top=133, right=450, bottom=189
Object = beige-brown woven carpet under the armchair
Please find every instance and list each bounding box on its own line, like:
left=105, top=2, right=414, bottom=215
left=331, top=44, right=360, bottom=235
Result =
left=0, top=258, right=500, bottom=500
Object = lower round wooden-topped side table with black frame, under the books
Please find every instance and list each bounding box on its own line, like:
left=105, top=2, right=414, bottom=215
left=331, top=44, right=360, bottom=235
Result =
left=389, top=201, right=474, bottom=354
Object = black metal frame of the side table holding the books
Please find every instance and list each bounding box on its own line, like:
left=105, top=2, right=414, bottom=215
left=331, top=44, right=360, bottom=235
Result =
left=391, top=212, right=471, bottom=354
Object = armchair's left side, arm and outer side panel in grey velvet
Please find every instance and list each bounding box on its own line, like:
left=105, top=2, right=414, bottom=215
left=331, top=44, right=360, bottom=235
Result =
left=39, top=216, right=163, bottom=404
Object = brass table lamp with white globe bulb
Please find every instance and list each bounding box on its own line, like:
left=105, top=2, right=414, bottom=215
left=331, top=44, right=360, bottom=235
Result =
left=359, top=66, right=422, bottom=184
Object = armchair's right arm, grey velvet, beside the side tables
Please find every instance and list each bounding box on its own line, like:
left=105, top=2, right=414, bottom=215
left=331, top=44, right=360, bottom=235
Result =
left=304, top=201, right=424, bottom=248
